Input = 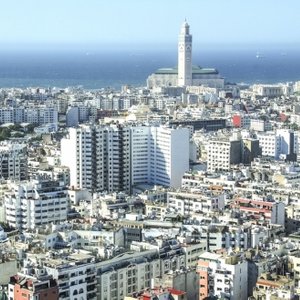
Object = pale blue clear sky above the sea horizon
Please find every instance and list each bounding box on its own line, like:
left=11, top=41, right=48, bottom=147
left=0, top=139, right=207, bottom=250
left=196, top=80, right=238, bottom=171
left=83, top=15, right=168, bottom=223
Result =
left=0, top=0, right=300, bottom=50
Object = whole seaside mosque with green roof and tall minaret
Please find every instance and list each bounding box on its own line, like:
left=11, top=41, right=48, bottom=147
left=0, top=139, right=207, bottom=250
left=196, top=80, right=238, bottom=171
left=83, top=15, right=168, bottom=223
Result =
left=147, top=21, right=224, bottom=88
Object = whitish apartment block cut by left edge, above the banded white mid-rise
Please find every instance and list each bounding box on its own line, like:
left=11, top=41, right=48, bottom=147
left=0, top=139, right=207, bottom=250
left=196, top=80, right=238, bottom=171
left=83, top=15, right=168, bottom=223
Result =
left=0, top=142, right=27, bottom=180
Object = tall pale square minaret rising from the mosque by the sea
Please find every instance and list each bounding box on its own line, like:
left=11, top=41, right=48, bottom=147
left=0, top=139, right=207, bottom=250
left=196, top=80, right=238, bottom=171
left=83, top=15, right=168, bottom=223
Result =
left=178, top=21, right=192, bottom=86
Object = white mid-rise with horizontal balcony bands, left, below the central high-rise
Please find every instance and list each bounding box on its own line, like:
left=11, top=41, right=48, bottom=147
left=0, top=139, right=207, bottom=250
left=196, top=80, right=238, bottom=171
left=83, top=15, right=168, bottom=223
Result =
left=4, top=178, right=69, bottom=230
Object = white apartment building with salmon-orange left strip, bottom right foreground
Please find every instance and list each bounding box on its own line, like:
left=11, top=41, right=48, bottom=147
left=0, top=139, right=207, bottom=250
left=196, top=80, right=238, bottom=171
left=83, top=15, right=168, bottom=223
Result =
left=197, top=252, right=248, bottom=300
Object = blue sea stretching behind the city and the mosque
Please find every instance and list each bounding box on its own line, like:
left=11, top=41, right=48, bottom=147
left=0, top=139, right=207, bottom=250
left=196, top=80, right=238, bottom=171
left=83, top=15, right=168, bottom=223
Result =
left=0, top=45, right=300, bottom=89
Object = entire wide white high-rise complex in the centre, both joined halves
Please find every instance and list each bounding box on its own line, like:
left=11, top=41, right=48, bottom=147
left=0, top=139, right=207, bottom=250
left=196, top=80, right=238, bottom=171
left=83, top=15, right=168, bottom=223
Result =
left=61, top=125, right=189, bottom=192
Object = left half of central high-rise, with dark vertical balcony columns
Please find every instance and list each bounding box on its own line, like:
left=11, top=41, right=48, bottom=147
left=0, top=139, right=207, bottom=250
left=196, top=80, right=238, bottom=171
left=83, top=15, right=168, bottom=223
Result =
left=61, top=125, right=130, bottom=192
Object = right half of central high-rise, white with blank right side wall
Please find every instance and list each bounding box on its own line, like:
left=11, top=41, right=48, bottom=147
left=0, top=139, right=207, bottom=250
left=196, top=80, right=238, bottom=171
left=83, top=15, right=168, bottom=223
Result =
left=130, top=126, right=189, bottom=187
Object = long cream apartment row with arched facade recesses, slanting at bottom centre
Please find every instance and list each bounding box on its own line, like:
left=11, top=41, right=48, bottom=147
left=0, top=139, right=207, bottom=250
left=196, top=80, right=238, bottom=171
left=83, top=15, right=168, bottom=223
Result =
left=96, top=240, right=185, bottom=300
